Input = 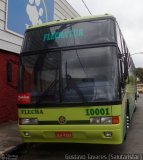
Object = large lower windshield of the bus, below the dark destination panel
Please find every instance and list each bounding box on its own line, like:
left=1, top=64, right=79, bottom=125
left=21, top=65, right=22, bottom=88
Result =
left=21, top=46, right=119, bottom=104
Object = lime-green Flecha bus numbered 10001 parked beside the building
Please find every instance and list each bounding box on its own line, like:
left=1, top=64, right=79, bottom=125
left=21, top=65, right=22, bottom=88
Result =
left=18, top=15, right=136, bottom=144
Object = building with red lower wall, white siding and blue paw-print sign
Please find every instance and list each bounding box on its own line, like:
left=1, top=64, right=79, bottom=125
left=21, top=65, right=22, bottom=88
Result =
left=0, top=0, right=79, bottom=123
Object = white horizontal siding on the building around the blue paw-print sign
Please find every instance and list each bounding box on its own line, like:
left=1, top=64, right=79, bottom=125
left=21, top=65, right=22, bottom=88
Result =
left=0, top=0, right=79, bottom=53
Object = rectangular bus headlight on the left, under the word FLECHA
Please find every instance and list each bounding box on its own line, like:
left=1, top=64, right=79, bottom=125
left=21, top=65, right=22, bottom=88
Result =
left=19, top=118, right=38, bottom=125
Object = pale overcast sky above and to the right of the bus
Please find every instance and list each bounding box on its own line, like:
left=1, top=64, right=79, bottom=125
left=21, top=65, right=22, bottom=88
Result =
left=67, top=0, right=143, bottom=68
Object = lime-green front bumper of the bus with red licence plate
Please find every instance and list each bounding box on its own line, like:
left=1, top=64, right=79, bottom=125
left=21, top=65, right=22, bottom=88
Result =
left=19, top=125, right=123, bottom=144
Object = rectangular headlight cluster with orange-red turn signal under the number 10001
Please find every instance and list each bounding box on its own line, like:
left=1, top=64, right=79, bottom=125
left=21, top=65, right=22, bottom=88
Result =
left=90, top=116, right=119, bottom=124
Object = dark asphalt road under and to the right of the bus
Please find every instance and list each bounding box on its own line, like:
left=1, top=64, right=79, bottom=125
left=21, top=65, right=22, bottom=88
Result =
left=18, top=94, right=143, bottom=160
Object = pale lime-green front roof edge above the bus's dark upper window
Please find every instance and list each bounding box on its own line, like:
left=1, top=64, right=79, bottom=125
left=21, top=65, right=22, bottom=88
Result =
left=26, top=14, right=115, bottom=31
